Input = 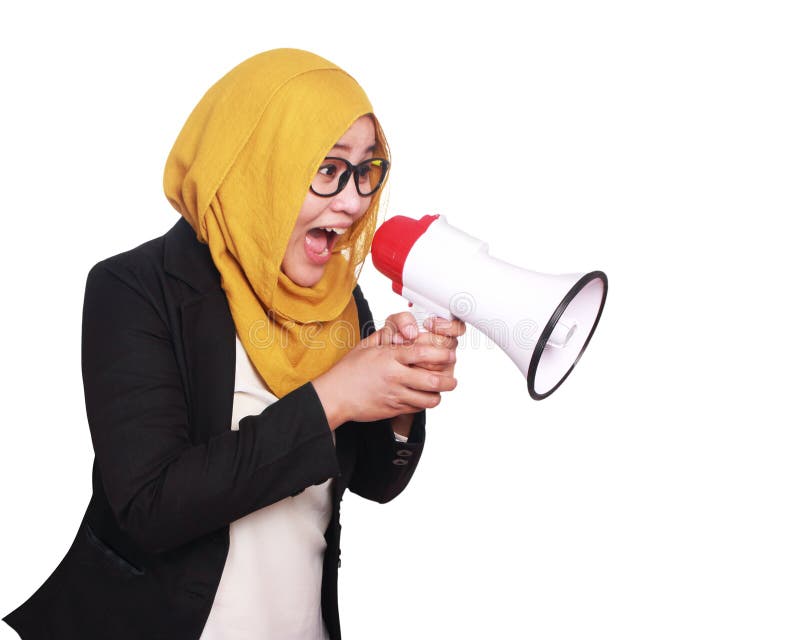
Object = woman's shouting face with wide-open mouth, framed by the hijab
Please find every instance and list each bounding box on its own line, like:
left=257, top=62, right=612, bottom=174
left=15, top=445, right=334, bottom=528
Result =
left=281, top=116, right=376, bottom=287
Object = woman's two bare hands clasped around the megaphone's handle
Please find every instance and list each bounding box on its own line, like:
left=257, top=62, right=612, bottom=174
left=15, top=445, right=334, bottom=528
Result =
left=312, top=327, right=456, bottom=430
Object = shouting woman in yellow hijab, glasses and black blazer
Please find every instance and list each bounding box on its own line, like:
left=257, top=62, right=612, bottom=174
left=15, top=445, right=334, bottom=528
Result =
left=6, top=49, right=464, bottom=640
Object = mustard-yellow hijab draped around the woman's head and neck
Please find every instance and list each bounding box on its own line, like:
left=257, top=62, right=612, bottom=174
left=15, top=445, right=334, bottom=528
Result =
left=164, top=49, right=388, bottom=398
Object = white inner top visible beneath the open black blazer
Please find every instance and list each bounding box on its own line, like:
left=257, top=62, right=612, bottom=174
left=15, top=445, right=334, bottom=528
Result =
left=200, top=336, right=331, bottom=640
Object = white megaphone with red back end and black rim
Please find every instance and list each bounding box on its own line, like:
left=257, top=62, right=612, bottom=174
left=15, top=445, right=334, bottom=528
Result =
left=372, top=215, right=608, bottom=400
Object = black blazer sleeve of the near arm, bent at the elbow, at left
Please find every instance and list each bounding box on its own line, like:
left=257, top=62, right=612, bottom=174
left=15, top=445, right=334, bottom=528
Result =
left=82, top=263, right=340, bottom=552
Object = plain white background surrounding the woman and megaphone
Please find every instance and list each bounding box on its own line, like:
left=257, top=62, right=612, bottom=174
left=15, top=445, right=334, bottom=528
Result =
left=0, top=0, right=800, bottom=640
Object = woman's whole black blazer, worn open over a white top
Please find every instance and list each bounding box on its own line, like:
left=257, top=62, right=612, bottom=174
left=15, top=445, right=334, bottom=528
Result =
left=5, top=219, right=425, bottom=640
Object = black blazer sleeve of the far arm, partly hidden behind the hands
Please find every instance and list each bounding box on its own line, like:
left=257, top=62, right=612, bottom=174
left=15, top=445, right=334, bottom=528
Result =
left=348, top=286, right=425, bottom=503
